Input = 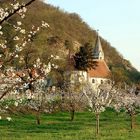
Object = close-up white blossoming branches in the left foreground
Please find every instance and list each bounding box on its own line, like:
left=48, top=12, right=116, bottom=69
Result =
left=0, top=0, right=51, bottom=120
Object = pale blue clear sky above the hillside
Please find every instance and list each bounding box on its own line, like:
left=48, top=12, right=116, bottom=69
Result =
left=46, top=0, right=140, bottom=71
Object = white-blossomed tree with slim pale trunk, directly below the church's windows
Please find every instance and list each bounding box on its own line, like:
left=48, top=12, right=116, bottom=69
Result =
left=83, top=83, right=117, bottom=135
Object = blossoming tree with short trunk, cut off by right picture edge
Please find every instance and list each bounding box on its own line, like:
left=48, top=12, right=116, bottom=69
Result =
left=114, top=86, right=140, bottom=129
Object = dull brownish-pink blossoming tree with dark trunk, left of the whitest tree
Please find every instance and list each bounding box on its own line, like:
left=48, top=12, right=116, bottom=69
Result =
left=61, top=79, right=86, bottom=121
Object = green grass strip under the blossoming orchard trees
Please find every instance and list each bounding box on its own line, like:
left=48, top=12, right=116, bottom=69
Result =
left=0, top=110, right=140, bottom=140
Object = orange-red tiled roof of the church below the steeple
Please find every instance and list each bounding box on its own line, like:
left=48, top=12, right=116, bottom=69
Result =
left=88, top=60, right=110, bottom=78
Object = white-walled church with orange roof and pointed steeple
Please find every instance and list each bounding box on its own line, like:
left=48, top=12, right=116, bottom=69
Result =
left=70, top=35, right=110, bottom=86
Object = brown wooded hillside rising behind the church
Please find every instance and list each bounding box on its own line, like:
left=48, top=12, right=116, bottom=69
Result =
left=1, top=1, right=140, bottom=83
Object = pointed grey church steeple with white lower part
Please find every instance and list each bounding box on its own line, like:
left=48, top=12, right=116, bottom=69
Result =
left=93, top=33, right=104, bottom=60
